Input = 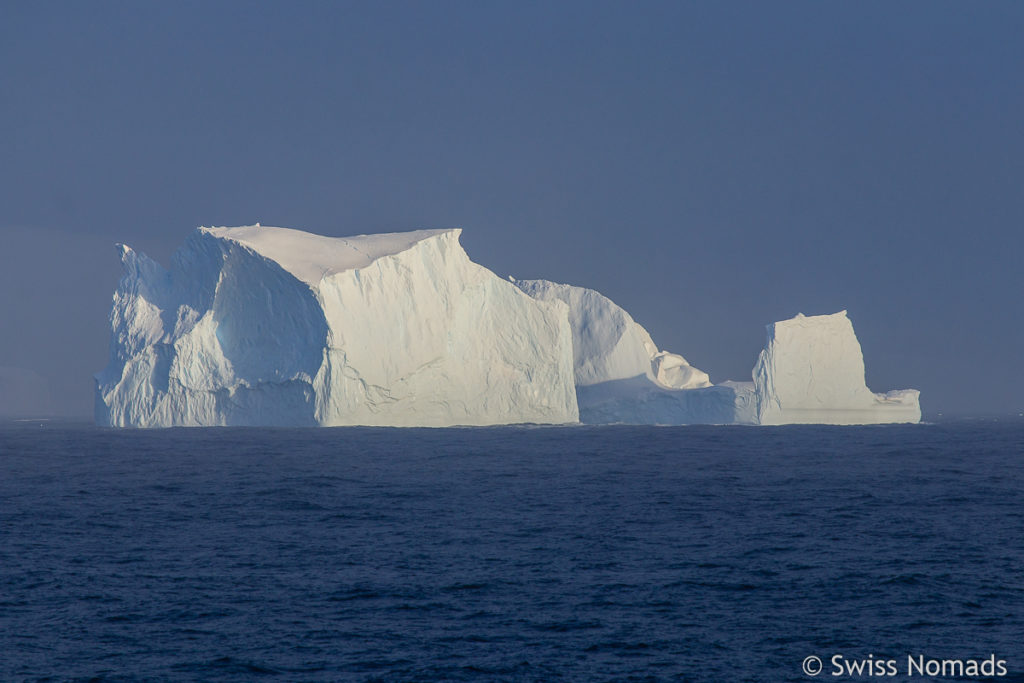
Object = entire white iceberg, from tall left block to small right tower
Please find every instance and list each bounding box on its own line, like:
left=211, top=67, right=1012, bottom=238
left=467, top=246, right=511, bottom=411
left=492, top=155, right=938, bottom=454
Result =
left=96, top=225, right=921, bottom=427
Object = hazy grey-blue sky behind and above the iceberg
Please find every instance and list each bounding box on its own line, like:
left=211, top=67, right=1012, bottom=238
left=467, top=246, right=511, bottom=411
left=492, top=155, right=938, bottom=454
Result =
left=0, top=0, right=1024, bottom=417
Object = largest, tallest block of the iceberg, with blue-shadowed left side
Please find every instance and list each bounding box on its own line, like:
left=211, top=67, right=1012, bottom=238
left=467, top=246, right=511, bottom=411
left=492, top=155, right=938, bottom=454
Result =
left=96, top=225, right=578, bottom=427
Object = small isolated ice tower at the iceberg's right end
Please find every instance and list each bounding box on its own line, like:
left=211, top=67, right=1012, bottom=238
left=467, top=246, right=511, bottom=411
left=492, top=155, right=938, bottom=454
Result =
left=754, top=310, right=921, bottom=425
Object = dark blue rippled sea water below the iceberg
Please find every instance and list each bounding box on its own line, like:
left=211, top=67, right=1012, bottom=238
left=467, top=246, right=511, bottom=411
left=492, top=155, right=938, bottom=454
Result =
left=0, top=420, right=1024, bottom=681
